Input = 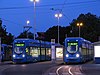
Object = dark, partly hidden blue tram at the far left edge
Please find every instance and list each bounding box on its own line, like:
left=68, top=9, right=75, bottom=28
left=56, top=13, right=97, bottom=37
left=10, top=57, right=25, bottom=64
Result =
left=1, top=44, right=12, bottom=62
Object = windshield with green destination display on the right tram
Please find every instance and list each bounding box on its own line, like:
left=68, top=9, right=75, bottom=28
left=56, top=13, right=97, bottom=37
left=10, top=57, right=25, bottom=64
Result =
left=67, top=42, right=78, bottom=53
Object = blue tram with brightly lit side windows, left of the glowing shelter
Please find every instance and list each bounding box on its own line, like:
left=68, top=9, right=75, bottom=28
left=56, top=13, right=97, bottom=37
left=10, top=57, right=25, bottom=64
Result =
left=13, top=39, right=51, bottom=63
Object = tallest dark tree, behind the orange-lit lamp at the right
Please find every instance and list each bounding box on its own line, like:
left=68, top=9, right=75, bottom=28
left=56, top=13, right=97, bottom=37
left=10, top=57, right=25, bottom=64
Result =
left=70, top=13, right=100, bottom=42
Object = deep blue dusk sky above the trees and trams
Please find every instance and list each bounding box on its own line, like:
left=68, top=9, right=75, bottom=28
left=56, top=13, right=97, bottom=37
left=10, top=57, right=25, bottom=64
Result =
left=0, top=0, right=100, bottom=36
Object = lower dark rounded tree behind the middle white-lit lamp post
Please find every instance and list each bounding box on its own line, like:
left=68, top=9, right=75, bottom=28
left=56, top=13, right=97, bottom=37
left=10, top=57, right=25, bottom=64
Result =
left=45, top=26, right=71, bottom=44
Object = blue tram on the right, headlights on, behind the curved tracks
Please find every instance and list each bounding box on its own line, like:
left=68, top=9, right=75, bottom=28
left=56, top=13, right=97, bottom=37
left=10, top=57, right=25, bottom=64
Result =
left=64, top=37, right=93, bottom=63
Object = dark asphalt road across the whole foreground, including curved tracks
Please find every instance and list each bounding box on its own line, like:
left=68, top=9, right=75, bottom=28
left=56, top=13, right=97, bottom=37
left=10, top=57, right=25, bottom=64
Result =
left=0, top=61, right=100, bottom=75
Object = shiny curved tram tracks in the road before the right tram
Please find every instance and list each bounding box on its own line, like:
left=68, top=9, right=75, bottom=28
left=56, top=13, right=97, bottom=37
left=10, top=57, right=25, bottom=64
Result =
left=43, top=65, right=84, bottom=75
